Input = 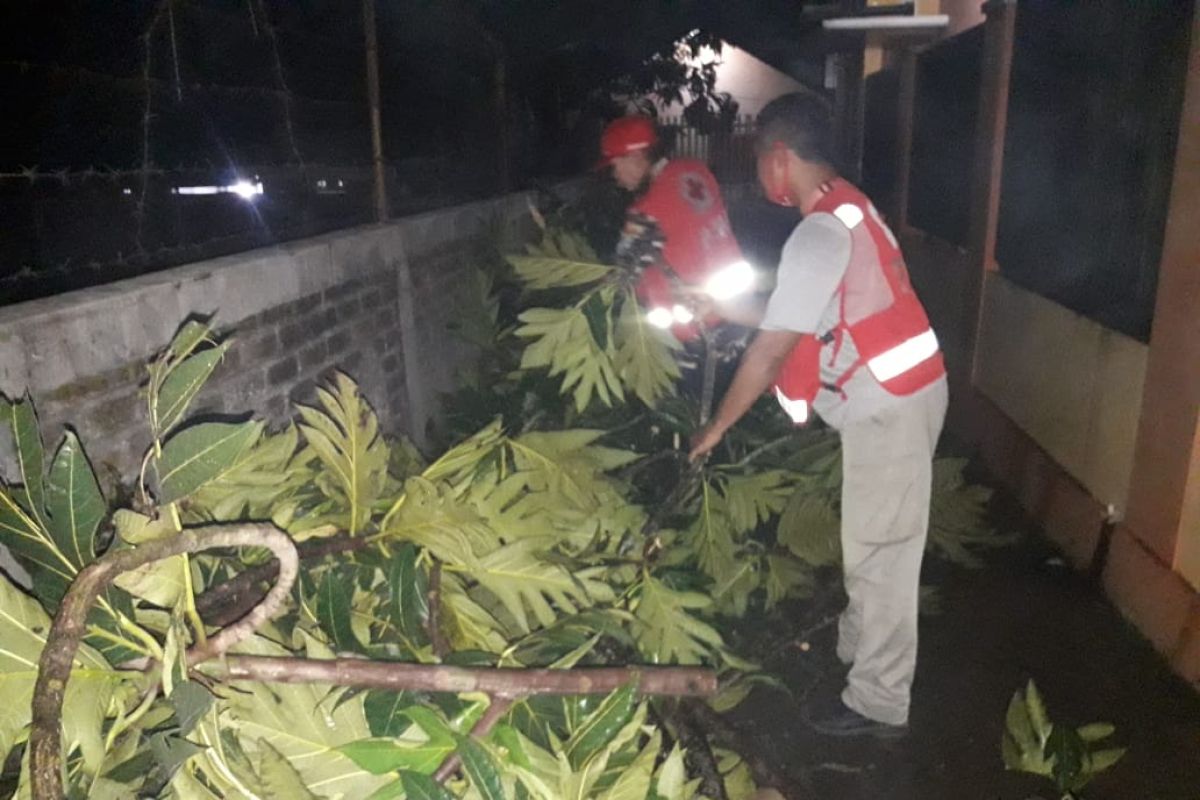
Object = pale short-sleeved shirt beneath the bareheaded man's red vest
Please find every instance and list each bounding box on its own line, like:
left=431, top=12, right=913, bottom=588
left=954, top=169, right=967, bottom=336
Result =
left=762, top=212, right=919, bottom=428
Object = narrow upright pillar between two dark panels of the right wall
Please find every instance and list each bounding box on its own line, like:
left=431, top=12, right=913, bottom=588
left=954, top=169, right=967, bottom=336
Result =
left=961, top=0, right=1016, bottom=384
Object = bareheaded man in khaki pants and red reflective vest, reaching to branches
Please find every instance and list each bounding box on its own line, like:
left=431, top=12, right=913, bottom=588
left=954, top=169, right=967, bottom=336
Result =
left=691, top=94, right=947, bottom=736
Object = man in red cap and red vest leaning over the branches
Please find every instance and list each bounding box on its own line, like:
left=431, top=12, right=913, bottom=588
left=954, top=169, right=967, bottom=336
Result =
left=600, top=116, right=755, bottom=359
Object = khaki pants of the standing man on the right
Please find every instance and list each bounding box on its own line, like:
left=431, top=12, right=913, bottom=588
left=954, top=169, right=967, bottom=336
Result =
left=838, top=380, right=947, bottom=724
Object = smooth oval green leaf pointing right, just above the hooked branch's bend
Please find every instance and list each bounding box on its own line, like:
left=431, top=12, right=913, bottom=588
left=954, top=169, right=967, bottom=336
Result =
left=158, top=422, right=263, bottom=505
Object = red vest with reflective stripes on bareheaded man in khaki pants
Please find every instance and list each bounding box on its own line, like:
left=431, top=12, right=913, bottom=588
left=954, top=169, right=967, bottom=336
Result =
left=775, top=179, right=946, bottom=423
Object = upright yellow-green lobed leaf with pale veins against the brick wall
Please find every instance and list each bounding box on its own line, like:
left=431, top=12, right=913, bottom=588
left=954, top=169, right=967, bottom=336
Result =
left=298, top=372, right=389, bottom=536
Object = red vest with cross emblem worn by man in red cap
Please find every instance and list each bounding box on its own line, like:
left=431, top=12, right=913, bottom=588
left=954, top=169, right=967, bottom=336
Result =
left=629, top=158, right=742, bottom=339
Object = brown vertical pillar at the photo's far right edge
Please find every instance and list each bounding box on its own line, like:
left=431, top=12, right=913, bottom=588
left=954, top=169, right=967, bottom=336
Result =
left=1124, top=0, right=1200, bottom=575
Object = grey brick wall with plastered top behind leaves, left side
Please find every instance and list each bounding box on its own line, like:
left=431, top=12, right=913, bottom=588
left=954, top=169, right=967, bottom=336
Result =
left=0, top=188, right=554, bottom=483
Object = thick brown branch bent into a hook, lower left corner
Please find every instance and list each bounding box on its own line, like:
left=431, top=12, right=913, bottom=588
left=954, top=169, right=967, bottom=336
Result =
left=29, top=524, right=300, bottom=800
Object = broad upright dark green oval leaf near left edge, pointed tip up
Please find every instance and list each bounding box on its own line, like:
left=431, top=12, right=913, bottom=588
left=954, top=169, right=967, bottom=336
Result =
left=46, top=431, right=108, bottom=569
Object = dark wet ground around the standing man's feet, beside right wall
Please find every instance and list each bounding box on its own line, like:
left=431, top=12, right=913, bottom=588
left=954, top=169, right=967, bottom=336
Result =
left=731, top=496, right=1200, bottom=800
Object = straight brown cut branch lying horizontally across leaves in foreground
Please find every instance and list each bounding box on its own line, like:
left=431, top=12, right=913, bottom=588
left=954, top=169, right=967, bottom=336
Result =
left=203, top=655, right=716, bottom=699
